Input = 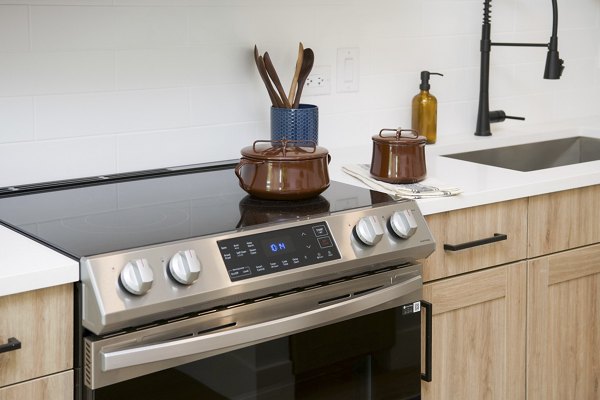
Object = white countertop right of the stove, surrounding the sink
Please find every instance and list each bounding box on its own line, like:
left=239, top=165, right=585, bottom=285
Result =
left=329, top=119, right=600, bottom=215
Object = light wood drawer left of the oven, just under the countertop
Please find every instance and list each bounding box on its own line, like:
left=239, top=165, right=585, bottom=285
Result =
left=0, top=284, right=73, bottom=388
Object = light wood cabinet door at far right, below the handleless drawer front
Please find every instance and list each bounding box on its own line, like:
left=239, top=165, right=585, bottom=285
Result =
left=527, top=245, right=600, bottom=400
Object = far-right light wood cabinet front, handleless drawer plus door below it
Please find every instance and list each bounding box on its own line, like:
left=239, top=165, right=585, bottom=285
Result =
left=527, top=185, right=600, bottom=400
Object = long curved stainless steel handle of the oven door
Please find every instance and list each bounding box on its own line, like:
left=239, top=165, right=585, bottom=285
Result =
left=100, top=276, right=423, bottom=372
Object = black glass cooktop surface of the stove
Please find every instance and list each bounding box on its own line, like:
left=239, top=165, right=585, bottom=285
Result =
left=0, top=165, right=392, bottom=259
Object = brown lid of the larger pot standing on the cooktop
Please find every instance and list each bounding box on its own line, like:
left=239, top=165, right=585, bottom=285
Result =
left=241, top=140, right=329, bottom=161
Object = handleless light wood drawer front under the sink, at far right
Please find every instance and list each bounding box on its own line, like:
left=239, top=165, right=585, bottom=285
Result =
left=528, top=185, right=600, bottom=258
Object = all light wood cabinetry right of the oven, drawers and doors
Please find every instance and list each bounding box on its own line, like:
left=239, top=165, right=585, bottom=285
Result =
left=422, top=185, right=600, bottom=400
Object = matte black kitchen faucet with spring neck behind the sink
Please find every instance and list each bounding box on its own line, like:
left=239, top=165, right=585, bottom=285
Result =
left=475, top=0, right=565, bottom=136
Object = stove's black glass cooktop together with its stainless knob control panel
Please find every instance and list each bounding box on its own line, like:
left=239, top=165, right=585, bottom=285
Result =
left=0, top=165, right=435, bottom=335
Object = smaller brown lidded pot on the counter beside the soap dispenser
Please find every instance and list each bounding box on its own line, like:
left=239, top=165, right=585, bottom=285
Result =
left=370, top=128, right=427, bottom=183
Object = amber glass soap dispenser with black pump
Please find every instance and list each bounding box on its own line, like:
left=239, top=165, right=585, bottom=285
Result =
left=412, top=71, right=444, bottom=144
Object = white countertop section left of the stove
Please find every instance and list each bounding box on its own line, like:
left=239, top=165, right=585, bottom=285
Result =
left=0, top=225, right=79, bottom=296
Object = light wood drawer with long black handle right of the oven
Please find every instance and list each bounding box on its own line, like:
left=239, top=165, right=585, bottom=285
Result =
left=423, top=199, right=527, bottom=281
